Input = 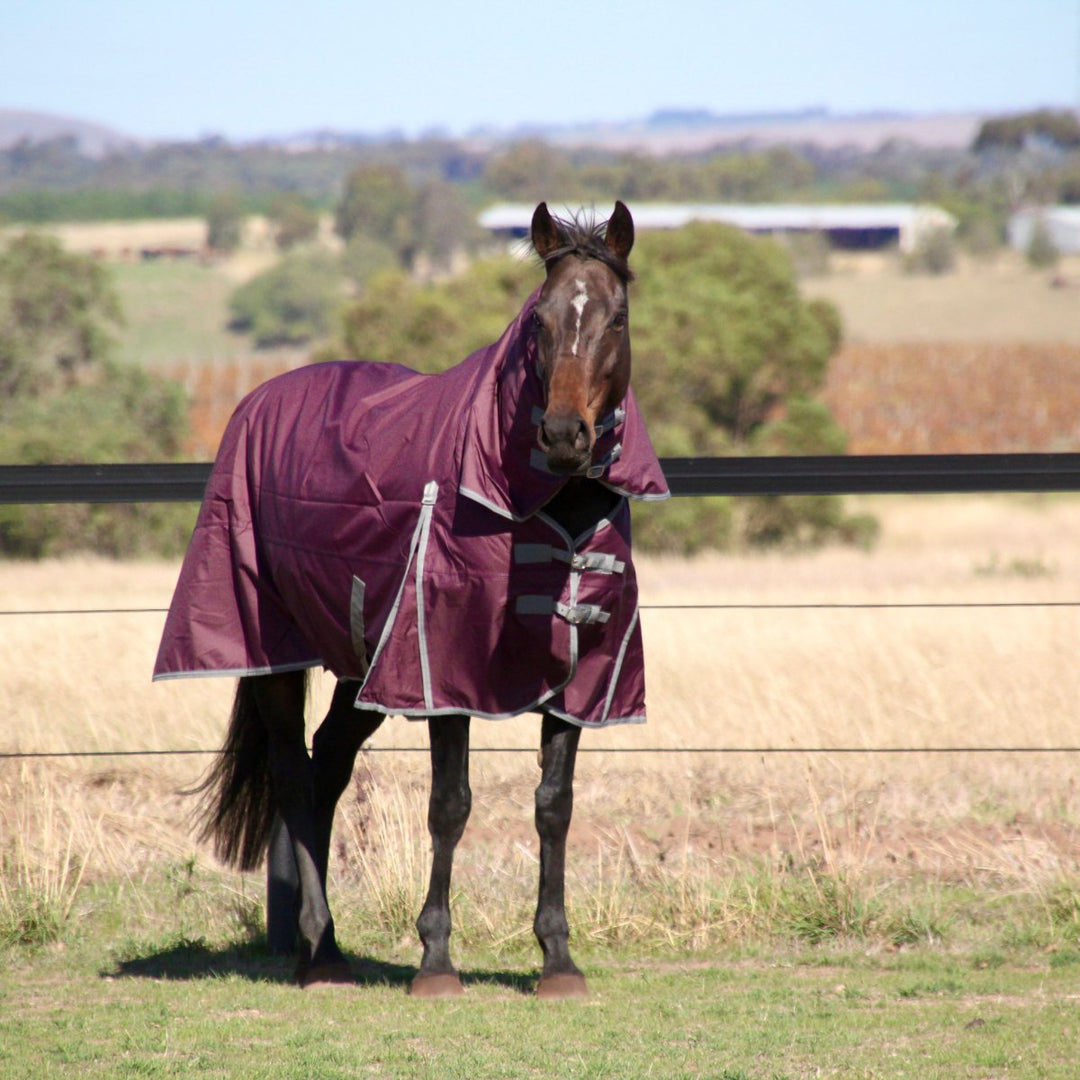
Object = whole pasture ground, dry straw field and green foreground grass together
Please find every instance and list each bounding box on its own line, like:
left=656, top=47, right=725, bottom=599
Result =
left=0, top=497, right=1080, bottom=1080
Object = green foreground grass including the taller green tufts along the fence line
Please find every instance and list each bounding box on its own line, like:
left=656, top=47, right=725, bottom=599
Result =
left=0, top=861, right=1080, bottom=1080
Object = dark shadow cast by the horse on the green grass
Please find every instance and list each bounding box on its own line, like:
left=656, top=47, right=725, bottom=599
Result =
left=102, top=939, right=536, bottom=995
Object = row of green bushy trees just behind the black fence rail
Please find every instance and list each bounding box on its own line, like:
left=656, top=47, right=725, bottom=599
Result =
left=0, top=212, right=873, bottom=556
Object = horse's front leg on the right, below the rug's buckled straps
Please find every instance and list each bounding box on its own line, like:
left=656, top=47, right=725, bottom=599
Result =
left=532, top=716, right=589, bottom=999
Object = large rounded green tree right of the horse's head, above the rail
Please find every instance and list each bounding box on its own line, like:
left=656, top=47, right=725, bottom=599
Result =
left=632, top=224, right=840, bottom=454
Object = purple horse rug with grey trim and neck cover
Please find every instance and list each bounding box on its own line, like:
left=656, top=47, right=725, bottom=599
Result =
left=154, top=291, right=670, bottom=727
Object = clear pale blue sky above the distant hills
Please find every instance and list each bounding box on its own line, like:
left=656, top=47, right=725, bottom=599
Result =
left=0, top=0, right=1080, bottom=138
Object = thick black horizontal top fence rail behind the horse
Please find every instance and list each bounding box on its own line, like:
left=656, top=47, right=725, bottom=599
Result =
left=6, top=454, right=1080, bottom=504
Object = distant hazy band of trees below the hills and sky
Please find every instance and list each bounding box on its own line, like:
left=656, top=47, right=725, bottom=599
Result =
left=0, top=110, right=1080, bottom=243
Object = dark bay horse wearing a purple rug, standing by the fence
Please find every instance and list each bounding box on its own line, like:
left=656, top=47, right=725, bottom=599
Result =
left=154, top=202, right=669, bottom=998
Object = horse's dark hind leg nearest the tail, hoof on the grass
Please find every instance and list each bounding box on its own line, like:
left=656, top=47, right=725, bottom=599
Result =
left=253, top=672, right=350, bottom=986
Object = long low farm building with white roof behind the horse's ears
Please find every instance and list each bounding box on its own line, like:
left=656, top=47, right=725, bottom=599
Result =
left=480, top=202, right=957, bottom=252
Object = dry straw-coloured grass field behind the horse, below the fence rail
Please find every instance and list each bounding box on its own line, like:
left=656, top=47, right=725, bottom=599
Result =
left=0, top=497, right=1080, bottom=948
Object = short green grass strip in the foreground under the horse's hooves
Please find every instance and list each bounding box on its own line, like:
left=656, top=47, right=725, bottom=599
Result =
left=0, top=941, right=1080, bottom=1080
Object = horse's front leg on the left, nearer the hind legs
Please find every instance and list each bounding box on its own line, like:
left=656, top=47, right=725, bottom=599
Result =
left=409, top=716, right=472, bottom=997
